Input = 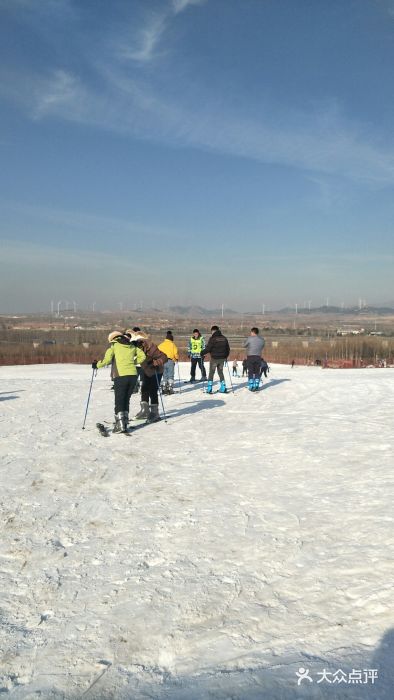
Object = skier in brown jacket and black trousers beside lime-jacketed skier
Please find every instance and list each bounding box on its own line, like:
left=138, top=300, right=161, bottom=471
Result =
left=130, top=331, right=168, bottom=423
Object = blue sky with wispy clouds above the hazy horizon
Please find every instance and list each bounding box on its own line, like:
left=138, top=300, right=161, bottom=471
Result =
left=0, top=0, right=394, bottom=312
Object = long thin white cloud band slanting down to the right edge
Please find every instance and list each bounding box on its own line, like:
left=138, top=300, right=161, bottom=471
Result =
left=3, top=61, right=394, bottom=185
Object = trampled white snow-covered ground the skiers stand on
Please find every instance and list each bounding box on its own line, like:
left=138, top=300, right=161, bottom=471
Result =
left=0, top=364, right=394, bottom=700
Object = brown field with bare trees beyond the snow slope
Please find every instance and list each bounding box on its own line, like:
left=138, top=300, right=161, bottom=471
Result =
left=0, top=312, right=394, bottom=368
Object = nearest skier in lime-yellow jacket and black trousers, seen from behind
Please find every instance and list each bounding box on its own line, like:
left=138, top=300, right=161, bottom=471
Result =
left=92, top=331, right=146, bottom=433
